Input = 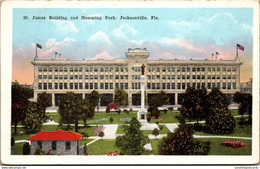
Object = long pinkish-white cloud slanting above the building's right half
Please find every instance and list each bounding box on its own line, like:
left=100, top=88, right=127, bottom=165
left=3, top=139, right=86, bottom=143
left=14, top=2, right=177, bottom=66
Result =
left=162, top=38, right=204, bottom=52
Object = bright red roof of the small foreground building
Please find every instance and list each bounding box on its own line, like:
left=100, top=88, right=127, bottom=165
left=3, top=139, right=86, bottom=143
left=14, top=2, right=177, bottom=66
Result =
left=27, top=129, right=83, bottom=140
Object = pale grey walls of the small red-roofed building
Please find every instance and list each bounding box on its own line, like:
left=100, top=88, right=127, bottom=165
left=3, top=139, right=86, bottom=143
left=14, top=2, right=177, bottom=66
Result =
left=31, top=140, right=79, bottom=155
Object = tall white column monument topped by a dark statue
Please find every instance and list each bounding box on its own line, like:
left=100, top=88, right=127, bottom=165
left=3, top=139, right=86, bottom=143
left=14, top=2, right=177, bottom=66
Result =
left=137, top=64, right=159, bottom=130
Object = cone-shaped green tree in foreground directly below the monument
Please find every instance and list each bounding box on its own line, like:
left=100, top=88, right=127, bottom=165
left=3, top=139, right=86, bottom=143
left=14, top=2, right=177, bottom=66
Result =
left=116, top=117, right=149, bottom=155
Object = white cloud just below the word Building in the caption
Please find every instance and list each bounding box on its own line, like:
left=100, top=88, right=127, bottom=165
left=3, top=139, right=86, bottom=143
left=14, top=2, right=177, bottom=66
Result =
left=50, top=20, right=78, bottom=33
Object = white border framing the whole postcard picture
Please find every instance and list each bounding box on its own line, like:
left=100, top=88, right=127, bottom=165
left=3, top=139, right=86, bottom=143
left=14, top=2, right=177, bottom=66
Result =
left=1, top=1, right=259, bottom=165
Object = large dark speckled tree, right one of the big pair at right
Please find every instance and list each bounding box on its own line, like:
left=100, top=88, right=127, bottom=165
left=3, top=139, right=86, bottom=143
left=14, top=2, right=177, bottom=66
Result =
left=205, top=88, right=235, bottom=134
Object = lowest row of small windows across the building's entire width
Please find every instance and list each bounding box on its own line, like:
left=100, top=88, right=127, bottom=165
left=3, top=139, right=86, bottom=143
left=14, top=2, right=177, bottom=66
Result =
left=38, top=82, right=236, bottom=90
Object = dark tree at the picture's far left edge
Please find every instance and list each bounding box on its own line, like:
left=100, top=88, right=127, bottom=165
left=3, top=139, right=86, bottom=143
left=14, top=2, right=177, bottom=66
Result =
left=12, top=81, right=33, bottom=134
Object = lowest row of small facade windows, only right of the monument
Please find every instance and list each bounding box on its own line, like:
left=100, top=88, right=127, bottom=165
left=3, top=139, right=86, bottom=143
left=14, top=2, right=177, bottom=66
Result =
left=147, top=82, right=236, bottom=90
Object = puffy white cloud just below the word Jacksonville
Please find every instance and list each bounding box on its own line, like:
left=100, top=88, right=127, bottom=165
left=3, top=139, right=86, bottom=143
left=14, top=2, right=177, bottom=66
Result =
left=113, top=24, right=138, bottom=39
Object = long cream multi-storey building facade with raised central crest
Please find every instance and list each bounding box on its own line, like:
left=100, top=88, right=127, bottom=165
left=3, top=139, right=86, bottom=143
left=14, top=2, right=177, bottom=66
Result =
left=32, top=48, right=242, bottom=107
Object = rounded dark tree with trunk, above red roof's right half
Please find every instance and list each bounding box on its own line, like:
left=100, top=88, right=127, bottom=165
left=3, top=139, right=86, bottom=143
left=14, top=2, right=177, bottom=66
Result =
left=58, top=92, right=82, bottom=132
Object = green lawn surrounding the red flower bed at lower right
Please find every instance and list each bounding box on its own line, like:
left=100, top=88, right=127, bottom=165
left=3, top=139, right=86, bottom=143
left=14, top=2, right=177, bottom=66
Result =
left=195, top=138, right=252, bottom=155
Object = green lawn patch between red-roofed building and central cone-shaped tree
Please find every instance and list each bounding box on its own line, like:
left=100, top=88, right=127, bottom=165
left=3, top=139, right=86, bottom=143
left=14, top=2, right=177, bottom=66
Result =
left=87, top=139, right=119, bottom=155
